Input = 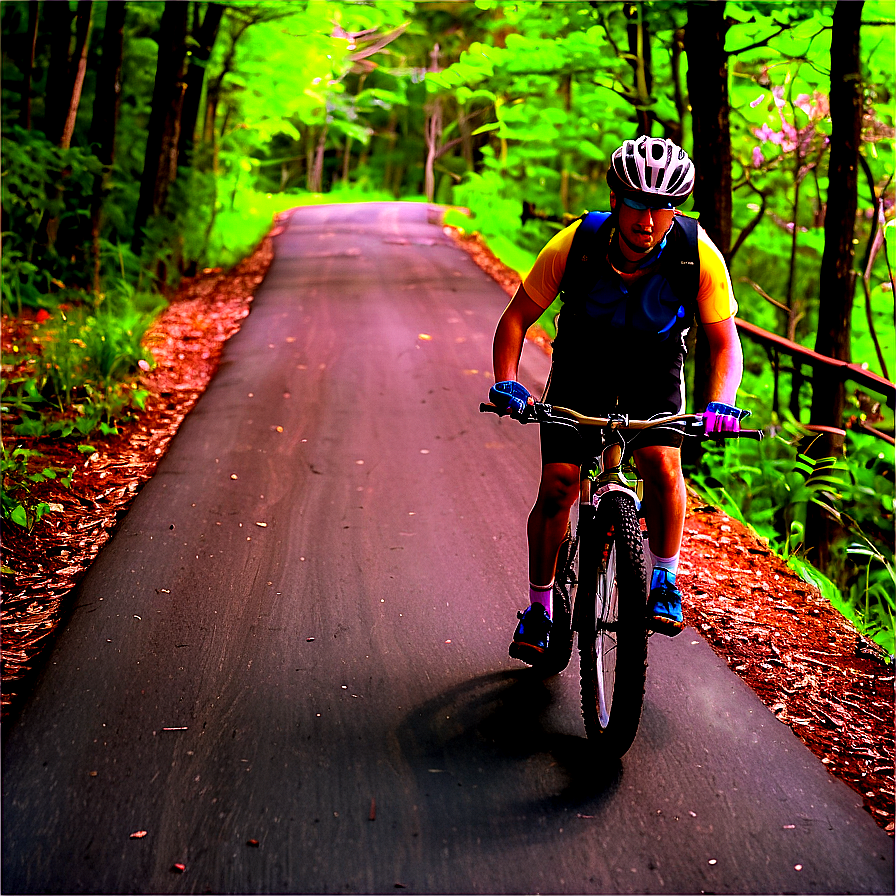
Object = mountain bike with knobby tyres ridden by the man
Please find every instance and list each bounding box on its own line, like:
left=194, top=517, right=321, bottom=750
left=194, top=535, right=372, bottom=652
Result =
left=479, top=402, right=762, bottom=757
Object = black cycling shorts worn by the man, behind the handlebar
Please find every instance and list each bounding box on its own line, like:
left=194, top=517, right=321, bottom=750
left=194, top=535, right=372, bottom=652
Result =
left=540, top=347, right=685, bottom=466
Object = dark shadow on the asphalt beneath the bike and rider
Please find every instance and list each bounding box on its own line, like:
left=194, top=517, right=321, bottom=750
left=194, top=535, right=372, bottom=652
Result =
left=396, top=669, right=622, bottom=841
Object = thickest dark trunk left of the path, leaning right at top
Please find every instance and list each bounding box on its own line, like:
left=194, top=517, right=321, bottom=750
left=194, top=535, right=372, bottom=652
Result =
left=131, top=0, right=189, bottom=255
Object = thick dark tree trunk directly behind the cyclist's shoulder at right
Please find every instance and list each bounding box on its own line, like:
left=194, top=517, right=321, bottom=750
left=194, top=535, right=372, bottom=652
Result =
left=685, top=2, right=731, bottom=410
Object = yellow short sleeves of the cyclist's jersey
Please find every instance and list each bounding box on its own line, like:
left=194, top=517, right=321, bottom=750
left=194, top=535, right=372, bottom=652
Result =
left=523, top=215, right=737, bottom=324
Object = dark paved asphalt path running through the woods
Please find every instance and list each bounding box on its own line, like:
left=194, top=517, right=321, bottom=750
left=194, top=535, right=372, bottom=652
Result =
left=2, top=203, right=894, bottom=894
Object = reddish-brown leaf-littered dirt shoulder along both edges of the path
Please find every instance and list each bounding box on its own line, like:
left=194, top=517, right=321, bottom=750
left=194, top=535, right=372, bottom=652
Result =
left=0, top=220, right=894, bottom=834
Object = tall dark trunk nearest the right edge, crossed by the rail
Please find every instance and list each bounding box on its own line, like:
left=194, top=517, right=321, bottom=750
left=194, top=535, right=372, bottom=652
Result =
left=806, top=0, right=864, bottom=566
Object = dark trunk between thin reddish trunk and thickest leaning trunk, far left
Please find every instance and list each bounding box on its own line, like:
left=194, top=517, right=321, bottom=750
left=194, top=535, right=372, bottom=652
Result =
left=88, top=0, right=127, bottom=292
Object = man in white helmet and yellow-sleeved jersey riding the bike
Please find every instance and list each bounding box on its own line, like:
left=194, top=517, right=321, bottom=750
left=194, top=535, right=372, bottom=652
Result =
left=489, top=137, right=749, bottom=664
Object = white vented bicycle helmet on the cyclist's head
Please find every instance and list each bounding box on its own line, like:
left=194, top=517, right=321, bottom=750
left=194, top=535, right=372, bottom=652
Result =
left=607, top=137, right=694, bottom=206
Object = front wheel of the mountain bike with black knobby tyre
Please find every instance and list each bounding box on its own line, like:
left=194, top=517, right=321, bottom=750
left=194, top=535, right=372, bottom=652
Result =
left=577, top=492, right=647, bottom=756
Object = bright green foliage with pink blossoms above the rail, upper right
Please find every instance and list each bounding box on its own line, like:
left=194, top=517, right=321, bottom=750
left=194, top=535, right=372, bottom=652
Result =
left=726, top=2, right=894, bottom=352
